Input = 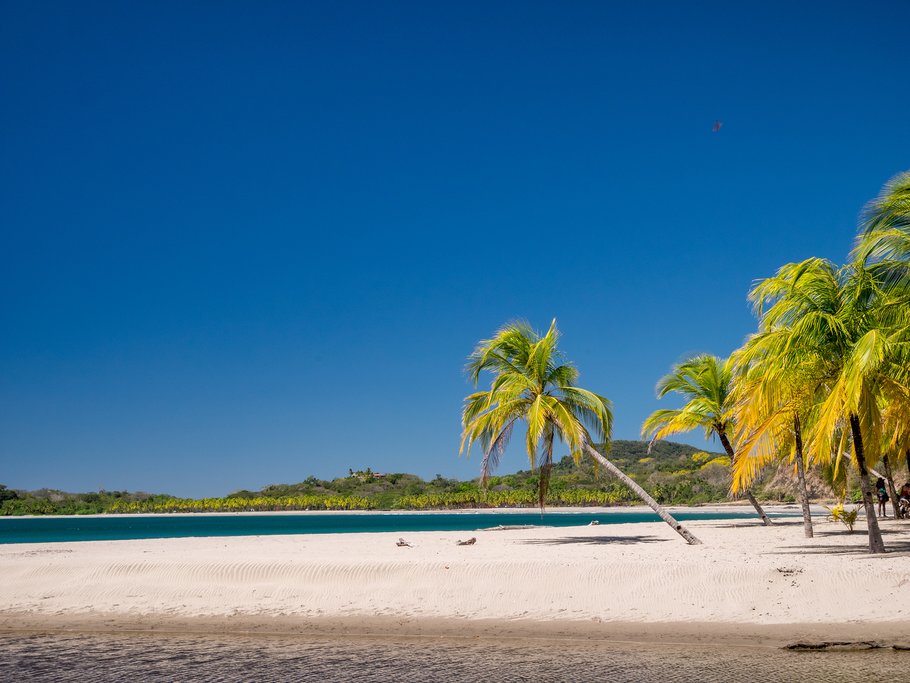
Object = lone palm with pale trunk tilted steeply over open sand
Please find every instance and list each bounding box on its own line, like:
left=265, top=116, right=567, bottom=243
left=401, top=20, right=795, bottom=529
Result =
left=461, top=320, right=701, bottom=545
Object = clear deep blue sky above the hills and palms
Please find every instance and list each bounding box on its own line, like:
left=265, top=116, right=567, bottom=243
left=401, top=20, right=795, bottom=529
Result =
left=0, top=0, right=910, bottom=495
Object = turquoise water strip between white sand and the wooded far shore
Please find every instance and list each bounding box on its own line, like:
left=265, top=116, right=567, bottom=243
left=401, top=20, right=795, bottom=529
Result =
left=0, top=511, right=792, bottom=543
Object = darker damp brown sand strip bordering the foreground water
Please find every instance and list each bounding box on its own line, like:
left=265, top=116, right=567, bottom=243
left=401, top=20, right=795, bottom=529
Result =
left=0, top=612, right=910, bottom=650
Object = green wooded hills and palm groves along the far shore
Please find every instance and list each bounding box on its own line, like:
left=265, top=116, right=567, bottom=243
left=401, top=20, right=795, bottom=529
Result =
left=0, top=441, right=828, bottom=516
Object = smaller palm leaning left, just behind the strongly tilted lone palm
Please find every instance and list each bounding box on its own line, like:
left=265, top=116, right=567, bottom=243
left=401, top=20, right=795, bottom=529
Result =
left=641, top=354, right=771, bottom=526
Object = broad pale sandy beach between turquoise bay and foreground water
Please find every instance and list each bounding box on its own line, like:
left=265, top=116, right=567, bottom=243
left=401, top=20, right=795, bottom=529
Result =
left=0, top=510, right=910, bottom=645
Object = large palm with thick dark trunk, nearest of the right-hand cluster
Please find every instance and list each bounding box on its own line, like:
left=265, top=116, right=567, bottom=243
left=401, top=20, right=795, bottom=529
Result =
left=740, top=258, right=910, bottom=553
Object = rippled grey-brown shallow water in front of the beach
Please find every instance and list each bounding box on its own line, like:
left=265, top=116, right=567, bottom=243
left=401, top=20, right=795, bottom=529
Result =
left=0, top=633, right=910, bottom=683
